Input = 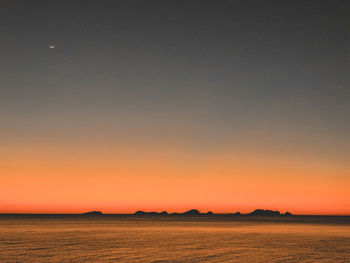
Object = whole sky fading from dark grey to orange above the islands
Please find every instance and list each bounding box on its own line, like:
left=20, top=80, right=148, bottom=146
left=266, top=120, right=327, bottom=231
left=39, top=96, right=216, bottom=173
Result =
left=0, top=0, right=350, bottom=215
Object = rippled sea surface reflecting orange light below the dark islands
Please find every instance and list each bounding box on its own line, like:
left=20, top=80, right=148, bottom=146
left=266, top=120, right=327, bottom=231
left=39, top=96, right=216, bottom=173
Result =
left=0, top=215, right=350, bottom=263
